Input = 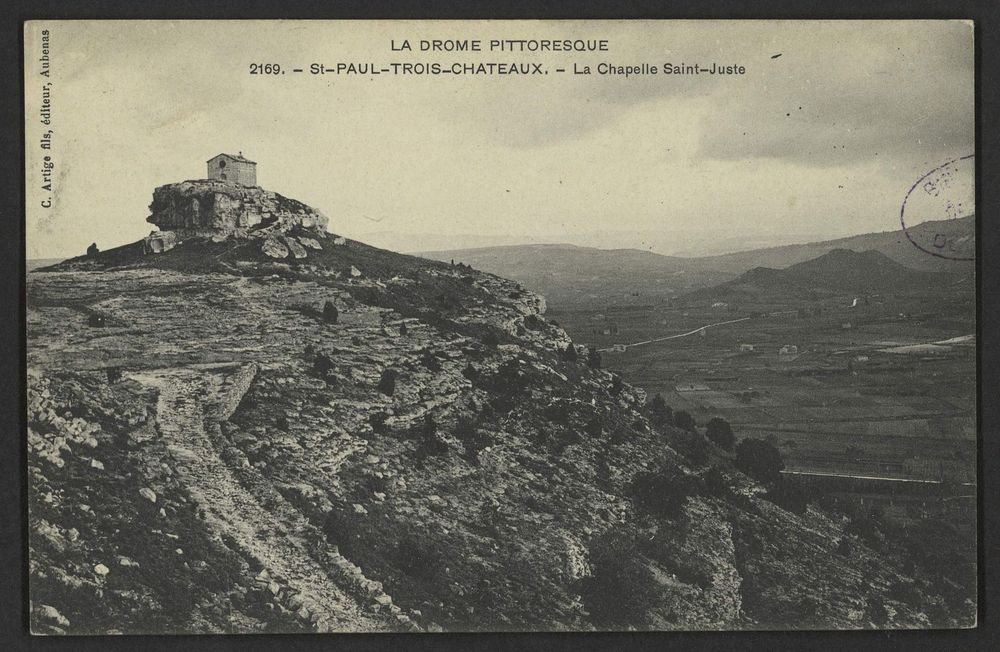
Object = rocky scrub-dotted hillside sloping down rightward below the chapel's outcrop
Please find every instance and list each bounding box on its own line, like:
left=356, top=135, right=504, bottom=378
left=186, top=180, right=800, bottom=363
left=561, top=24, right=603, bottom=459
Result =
left=27, top=184, right=974, bottom=633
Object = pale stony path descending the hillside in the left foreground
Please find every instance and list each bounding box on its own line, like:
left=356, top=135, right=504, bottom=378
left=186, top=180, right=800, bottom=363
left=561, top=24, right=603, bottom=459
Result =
left=130, top=369, right=386, bottom=632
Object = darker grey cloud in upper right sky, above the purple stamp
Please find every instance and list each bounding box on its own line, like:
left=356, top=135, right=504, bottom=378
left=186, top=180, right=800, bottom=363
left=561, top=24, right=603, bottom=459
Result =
left=700, top=22, right=974, bottom=167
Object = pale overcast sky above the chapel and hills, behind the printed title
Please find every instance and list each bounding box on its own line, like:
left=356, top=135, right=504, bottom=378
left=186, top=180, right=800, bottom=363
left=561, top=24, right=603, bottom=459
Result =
left=25, top=21, right=974, bottom=258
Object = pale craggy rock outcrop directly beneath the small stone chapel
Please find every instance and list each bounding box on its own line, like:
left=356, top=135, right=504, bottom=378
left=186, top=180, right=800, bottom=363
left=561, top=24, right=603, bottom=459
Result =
left=146, top=179, right=327, bottom=238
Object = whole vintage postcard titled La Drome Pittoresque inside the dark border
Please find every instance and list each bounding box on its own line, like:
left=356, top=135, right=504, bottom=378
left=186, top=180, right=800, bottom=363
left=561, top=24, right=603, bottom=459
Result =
left=23, top=20, right=978, bottom=635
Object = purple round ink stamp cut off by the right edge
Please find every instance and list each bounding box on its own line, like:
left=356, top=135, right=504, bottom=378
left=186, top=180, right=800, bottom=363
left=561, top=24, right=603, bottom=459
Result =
left=899, top=154, right=976, bottom=260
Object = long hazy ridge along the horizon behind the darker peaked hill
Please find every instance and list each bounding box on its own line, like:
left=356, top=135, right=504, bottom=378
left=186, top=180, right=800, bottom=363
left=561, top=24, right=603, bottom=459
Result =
left=420, top=216, right=975, bottom=305
